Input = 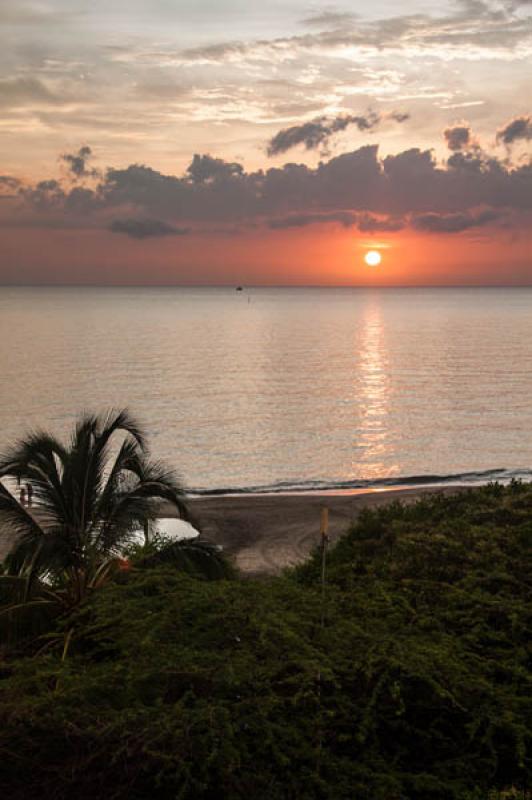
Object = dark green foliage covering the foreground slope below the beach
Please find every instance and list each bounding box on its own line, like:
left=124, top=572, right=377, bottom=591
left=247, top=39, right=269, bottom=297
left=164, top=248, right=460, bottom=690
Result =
left=0, top=484, right=532, bottom=800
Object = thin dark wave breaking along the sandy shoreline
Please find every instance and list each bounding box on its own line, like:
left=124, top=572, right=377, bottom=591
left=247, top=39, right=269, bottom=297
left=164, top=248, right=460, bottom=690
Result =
left=188, top=469, right=532, bottom=497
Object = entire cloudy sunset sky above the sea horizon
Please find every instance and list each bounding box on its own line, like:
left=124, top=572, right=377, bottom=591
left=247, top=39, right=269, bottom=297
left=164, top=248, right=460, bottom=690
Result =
left=0, top=0, right=532, bottom=285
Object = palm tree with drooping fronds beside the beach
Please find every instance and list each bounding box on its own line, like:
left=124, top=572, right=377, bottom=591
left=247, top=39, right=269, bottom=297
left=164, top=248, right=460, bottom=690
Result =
left=0, top=410, right=228, bottom=644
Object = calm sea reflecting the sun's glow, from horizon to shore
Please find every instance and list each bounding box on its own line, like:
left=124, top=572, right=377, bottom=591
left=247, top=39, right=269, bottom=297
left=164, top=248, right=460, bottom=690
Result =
left=0, top=288, right=532, bottom=490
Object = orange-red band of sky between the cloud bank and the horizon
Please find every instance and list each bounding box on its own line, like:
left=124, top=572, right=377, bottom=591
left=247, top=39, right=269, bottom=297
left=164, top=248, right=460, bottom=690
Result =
left=0, top=225, right=531, bottom=286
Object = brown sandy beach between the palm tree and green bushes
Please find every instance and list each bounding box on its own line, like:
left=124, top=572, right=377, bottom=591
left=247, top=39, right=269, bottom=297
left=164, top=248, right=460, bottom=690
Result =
left=185, top=486, right=461, bottom=575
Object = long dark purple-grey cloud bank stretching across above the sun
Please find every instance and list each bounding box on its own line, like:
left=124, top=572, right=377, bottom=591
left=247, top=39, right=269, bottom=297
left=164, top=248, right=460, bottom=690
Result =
left=10, top=131, right=532, bottom=238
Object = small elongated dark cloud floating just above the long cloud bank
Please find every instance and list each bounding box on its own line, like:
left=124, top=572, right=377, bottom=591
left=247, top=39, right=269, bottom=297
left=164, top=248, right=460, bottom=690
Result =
left=267, top=111, right=409, bottom=156
